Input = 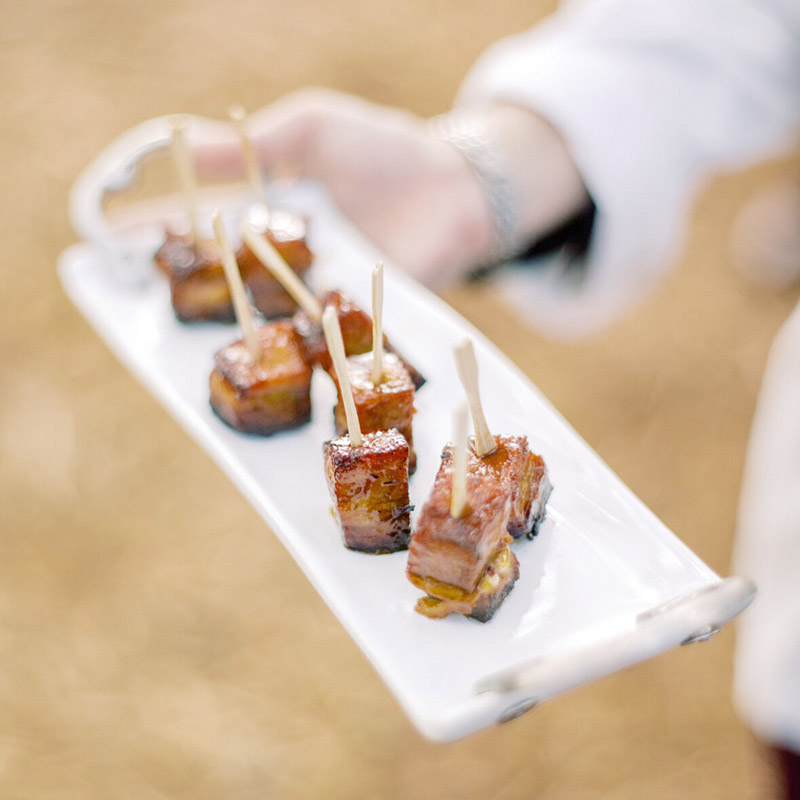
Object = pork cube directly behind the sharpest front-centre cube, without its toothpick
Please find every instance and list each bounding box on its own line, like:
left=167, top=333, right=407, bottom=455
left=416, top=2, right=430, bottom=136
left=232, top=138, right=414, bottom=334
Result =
left=332, top=352, right=417, bottom=474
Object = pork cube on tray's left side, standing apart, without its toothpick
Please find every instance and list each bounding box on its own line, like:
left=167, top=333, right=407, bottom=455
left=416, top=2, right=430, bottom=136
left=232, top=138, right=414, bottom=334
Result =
left=209, top=320, right=312, bottom=436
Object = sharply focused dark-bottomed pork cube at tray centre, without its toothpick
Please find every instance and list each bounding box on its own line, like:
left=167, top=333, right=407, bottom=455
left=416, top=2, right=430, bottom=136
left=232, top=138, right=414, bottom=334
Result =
left=323, top=430, right=413, bottom=553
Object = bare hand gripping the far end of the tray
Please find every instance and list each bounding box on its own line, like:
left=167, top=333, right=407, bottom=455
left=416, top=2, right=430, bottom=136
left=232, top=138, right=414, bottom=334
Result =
left=196, top=90, right=493, bottom=287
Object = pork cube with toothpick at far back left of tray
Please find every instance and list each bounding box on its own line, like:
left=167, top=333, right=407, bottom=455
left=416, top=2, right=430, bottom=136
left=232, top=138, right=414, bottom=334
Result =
left=154, top=117, right=235, bottom=322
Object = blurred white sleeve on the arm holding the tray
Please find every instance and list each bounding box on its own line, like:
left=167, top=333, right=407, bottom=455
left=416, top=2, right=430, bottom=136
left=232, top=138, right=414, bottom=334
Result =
left=458, top=0, right=800, bottom=336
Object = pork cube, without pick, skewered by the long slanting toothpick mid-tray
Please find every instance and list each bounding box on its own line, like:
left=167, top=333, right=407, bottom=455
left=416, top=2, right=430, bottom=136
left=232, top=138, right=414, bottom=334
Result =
left=294, top=289, right=425, bottom=389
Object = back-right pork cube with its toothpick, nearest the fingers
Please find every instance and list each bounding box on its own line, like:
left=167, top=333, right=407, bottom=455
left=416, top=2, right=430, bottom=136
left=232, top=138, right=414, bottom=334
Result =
left=229, top=106, right=314, bottom=318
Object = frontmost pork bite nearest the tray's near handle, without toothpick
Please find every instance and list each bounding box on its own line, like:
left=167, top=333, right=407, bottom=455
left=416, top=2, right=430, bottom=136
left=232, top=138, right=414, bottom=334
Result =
left=406, top=471, right=519, bottom=622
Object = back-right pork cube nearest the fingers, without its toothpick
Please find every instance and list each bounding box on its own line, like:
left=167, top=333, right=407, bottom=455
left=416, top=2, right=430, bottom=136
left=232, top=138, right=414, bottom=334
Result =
left=236, top=209, right=314, bottom=317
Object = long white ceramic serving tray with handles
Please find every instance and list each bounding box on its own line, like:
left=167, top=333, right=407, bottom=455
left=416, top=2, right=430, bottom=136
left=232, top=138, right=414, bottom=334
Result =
left=59, top=115, right=753, bottom=741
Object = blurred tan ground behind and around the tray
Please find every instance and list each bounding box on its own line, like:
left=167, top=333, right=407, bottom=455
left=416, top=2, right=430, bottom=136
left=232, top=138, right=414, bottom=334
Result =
left=0, top=0, right=797, bottom=800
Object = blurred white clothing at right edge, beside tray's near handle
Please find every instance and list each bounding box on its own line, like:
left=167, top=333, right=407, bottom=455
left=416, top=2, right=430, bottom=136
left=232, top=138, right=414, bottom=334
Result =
left=734, top=305, right=800, bottom=753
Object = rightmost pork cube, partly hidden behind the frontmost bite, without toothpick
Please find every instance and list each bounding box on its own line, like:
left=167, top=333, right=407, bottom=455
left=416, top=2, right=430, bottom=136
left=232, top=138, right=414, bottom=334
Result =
left=439, top=434, right=552, bottom=538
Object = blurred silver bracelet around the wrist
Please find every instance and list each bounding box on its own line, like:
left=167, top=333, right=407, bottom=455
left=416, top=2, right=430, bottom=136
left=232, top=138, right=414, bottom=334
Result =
left=428, top=109, right=523, bottom=263
